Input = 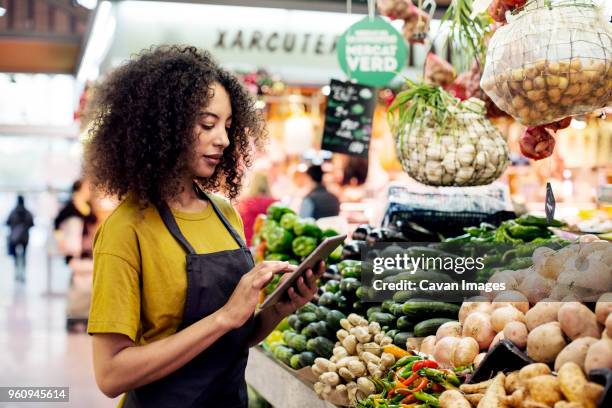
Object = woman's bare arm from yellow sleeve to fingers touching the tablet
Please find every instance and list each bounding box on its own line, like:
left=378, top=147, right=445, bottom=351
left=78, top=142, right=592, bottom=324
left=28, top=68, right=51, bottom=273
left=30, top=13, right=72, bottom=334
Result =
left=93, top=262, right=289, bottom=398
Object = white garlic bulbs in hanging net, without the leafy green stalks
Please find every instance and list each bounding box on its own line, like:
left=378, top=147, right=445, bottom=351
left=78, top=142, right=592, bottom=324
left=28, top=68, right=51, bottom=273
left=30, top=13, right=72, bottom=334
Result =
left=396, top=98, right=509, bottom=186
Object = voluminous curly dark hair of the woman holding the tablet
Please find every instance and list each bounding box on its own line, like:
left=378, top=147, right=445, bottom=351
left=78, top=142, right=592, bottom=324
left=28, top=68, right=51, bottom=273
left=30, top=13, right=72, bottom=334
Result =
left=85, top=45, right=266, bottom=206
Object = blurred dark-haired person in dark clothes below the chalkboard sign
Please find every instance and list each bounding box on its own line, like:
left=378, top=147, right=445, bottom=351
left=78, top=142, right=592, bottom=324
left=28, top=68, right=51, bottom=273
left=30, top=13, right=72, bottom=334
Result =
left=300, top=166, right=340, bottom=220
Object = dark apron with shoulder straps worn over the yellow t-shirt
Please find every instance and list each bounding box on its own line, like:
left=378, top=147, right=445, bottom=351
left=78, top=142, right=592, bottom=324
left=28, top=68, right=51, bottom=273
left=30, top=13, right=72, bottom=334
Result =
left=123, top=188, right=254, bottom=408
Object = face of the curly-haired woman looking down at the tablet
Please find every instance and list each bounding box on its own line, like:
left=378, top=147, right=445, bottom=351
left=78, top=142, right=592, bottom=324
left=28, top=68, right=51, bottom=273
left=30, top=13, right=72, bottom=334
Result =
left=189, top=83, right=232, bottom=178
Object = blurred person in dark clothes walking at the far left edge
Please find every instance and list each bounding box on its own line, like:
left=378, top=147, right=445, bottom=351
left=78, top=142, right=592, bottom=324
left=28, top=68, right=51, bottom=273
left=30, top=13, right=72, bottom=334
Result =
left=6, top=194, right=34, bottom=282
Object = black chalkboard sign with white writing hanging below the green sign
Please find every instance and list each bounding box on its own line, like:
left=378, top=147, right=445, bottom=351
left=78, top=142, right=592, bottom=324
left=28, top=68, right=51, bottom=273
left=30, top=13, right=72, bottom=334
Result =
left=321, top=79, right=376, bottom=157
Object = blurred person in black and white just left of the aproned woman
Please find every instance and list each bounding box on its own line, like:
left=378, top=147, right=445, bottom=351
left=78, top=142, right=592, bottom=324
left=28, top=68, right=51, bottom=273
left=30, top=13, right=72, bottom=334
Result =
left=54, top=180, right=97, bottom=263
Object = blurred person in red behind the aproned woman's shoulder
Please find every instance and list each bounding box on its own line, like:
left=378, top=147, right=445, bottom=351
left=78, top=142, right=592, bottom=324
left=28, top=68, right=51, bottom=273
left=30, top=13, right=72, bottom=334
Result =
left=236, top=173, right=277, bottom=246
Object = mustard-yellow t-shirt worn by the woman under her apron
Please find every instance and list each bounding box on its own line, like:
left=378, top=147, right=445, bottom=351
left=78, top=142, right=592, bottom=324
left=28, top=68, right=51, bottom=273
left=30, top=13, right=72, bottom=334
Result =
left=87, top=194, right=244, bottom=345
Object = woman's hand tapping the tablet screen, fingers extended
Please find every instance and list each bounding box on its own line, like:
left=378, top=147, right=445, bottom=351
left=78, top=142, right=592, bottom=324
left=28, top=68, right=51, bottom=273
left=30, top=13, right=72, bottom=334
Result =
left=220, top=261, right=295, bottom=329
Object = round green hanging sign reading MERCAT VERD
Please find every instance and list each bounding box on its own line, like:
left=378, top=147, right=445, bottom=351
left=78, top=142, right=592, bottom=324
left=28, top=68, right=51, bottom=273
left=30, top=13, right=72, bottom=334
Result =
left=338, top=17, right=406, bottom=87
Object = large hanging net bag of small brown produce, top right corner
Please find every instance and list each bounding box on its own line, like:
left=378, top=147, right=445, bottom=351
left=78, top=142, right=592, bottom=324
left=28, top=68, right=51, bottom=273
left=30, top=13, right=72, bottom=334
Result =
left=481, top=0, right=612, bottom=126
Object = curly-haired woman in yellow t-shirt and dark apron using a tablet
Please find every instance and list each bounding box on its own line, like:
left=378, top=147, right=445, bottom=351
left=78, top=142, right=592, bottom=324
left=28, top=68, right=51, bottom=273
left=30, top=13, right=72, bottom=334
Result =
left=86, top=46, right=324, bottom=408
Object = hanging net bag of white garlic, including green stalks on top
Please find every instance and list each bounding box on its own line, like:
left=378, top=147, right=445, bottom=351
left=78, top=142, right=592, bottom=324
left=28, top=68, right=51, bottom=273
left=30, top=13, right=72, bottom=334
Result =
left=388, top=82, right=509, bottom=186
